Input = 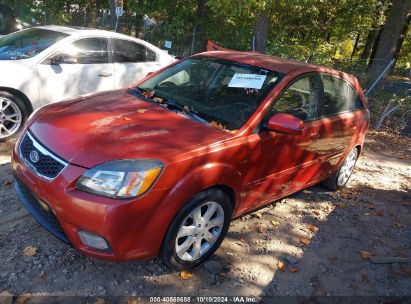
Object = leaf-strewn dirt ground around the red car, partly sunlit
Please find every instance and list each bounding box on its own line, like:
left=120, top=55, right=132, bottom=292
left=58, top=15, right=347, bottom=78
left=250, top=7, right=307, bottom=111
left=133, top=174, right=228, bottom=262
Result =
left=0, top=132, right=411, bottom=301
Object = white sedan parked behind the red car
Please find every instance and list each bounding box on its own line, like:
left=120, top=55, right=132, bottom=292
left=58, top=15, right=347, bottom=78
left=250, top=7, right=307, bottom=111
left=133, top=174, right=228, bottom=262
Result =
left=0, top=26, right=175, bottom=141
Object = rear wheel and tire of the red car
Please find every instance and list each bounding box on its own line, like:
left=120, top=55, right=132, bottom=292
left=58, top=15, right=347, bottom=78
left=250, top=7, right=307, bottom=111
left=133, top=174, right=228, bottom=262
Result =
left=322, top=148, right=358, bottom=191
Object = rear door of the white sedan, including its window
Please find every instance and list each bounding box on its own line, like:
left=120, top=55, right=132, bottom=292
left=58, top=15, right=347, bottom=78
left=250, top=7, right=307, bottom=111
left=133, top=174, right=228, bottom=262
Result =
left=111, top=38, right=165, bottom=89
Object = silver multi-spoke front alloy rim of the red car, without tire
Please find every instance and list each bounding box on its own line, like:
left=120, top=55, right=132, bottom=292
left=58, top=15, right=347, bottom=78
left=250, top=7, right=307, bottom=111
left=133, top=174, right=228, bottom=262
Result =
left=175, top=202, right=224, bottom=261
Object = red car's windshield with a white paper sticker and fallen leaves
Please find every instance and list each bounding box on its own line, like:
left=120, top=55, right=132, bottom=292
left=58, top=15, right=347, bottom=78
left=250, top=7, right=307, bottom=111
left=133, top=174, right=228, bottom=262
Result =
left=138, top=56, right=280, bottom=133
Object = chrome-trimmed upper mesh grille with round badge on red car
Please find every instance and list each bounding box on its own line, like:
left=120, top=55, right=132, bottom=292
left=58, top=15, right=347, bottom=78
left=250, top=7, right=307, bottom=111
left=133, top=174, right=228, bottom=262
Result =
left=20, top=132, right=67, bottom=180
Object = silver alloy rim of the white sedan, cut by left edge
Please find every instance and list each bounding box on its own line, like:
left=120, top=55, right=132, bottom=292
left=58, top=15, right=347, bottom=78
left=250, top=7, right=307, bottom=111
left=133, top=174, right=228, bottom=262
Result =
left=0, top=96, right=22, bottom=139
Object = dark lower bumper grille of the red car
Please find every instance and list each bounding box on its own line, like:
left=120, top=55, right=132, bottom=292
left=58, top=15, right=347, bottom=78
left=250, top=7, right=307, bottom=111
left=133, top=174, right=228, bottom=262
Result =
left=15, top=177, right=69, bottom=243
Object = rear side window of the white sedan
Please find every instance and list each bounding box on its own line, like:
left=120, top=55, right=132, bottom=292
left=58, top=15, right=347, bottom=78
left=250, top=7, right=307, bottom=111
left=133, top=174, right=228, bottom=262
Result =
left=113, top=39, right=156, bottom=63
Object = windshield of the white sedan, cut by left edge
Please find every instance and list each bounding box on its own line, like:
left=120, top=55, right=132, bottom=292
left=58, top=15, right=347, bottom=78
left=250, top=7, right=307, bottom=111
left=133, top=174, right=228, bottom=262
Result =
left=0, top=28, right=68, bottom=60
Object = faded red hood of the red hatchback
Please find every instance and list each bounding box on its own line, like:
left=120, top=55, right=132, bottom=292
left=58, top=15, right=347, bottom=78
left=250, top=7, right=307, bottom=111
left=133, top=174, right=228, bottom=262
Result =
left=29, top=90, right=230, bottom=168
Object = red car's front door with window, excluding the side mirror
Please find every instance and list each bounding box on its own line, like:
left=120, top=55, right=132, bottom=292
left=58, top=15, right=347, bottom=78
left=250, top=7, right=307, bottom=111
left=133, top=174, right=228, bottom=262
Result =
left=241, top=74, right=322, bottom=208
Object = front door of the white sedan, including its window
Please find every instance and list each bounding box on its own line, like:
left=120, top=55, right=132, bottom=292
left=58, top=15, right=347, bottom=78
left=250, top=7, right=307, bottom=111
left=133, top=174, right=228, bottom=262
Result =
left=37, top=37, right=114, bottom=104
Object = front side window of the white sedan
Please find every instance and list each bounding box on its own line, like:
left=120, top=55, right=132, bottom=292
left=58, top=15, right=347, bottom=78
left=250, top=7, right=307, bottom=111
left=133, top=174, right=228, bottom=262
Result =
left=69, top=38, right=108, bottom=64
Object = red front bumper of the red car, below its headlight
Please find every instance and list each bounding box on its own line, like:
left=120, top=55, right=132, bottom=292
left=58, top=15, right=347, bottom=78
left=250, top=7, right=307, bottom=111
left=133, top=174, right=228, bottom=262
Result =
left=12, top=142, right=169, bottom=261
